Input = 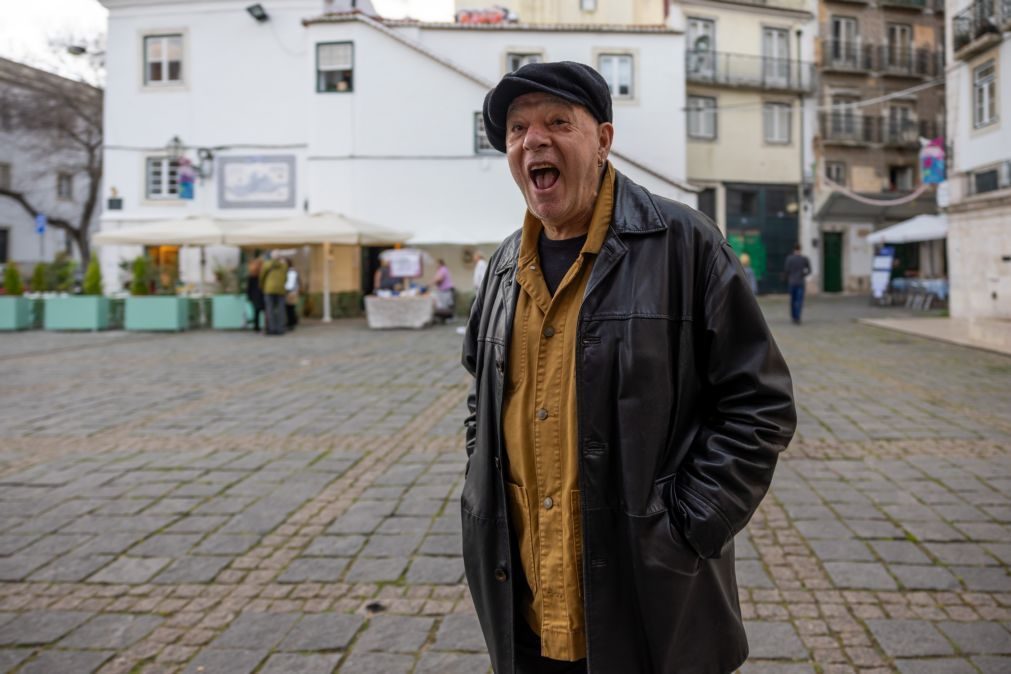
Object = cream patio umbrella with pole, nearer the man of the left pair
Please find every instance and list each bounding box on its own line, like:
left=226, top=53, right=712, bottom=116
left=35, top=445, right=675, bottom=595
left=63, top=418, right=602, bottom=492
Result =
left=224, top=211, right=411, bottom=322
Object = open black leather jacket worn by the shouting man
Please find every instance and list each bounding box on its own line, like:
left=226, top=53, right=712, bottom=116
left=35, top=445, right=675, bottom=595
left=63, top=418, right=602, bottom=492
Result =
left=461, top=174, right=797, bottom=674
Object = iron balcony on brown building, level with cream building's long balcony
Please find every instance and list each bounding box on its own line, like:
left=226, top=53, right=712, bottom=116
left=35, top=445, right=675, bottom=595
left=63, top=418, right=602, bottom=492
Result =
left=822, top=40, right=942, bottom=78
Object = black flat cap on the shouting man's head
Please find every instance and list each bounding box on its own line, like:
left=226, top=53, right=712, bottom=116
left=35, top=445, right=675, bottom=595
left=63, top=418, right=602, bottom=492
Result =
left=484, top=61, right=613, bottom=153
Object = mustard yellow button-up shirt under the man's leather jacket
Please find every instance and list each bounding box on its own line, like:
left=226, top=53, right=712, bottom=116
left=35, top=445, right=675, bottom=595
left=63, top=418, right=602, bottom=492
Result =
left=502, top=164, right=615, bottom=661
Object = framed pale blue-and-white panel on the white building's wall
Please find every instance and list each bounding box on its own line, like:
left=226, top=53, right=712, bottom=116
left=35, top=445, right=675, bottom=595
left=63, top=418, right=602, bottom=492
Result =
left=217, top=155, right=295, bottom=208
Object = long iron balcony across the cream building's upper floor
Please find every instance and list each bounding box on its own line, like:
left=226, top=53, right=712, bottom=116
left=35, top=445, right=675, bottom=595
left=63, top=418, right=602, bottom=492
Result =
left=684, top=51, right=814, bottom=93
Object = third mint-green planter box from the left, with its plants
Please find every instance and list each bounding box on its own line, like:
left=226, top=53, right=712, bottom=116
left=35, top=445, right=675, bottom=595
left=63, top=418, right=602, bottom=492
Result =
left=123, top=256, right=189, bottom=332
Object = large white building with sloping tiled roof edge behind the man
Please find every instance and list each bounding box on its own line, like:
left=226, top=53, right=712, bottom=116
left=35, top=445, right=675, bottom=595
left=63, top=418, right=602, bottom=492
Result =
left=96, top=0, right=695, bottom=289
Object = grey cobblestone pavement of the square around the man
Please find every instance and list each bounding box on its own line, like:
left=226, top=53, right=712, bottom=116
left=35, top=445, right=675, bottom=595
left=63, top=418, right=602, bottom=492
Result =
left=0, top=299, right=1011, bottom=674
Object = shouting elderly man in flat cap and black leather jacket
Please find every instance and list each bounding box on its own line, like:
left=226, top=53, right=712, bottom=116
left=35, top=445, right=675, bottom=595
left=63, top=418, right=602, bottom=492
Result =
left=461, top=63, right=796, bottom=674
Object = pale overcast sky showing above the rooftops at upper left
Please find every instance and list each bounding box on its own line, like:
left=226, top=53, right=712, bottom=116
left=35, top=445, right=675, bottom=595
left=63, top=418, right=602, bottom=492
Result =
left=0, top=0, right=452, bottom=75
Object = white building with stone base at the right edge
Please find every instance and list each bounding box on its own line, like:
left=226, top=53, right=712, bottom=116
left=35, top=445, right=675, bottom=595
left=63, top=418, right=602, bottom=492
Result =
left=946, top=0, right=1011, bottom=323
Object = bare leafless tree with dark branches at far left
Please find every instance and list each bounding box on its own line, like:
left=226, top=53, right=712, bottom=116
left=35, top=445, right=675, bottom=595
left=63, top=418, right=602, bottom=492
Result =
left=0, top=37, right=103, bottom=264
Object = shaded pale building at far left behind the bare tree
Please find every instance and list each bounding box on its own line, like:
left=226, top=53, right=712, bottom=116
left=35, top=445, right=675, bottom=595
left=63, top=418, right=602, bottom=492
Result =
left=0, top=59, right=101, bottom=275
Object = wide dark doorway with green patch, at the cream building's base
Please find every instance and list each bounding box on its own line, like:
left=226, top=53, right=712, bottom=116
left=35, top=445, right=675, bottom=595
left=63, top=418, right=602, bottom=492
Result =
left=727, top=185, right=799, bottom=293
